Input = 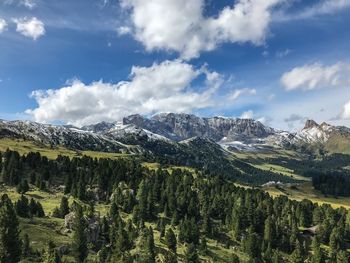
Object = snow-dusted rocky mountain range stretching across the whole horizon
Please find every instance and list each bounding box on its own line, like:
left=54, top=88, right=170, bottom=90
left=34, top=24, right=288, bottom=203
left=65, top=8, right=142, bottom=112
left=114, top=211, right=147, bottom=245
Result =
left=0, top=113, right=350, bottom=153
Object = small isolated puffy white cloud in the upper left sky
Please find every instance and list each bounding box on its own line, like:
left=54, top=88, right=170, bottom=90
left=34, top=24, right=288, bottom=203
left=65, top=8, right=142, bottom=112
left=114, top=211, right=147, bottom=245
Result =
left=13, top=17, right=45, bottom=40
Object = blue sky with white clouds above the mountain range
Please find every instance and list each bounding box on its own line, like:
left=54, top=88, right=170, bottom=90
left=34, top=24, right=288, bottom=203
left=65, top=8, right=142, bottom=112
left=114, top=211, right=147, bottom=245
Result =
left=0, top=0, right=350, bottom=131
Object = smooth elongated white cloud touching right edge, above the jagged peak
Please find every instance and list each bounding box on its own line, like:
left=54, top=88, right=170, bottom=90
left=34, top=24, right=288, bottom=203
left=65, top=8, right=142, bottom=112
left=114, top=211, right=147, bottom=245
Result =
left=281, top=62, right=350, bottom=90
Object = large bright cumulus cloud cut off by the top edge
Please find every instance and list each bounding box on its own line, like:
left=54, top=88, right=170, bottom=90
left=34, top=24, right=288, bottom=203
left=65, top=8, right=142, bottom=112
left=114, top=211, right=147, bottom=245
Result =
left=121, top=0, right=282, bottom=59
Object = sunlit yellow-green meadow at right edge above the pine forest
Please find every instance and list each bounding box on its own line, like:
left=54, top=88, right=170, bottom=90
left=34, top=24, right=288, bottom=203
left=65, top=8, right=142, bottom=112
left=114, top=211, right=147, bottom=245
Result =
left=264, top=182, right=350, bottom=209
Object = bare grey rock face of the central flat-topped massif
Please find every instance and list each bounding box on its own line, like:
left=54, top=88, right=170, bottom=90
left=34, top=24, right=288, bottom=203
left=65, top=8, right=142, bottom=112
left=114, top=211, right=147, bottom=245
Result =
left=123, top=113, right=274, bottom=141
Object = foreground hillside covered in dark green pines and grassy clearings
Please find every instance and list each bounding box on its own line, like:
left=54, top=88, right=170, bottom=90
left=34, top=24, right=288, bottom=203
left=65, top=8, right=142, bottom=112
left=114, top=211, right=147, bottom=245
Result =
left=0, top=151, right=350, bottom=263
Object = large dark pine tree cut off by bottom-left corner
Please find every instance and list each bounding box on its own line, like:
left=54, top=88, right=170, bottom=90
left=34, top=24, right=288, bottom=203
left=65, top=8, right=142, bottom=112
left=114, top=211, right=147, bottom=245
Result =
left=0, top=195, right=22, bottom=263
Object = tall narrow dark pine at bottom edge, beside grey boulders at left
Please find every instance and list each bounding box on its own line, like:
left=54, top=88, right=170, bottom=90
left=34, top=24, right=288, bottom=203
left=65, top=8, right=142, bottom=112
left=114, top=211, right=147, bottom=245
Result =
left=72, top=204, right=88, bottom=263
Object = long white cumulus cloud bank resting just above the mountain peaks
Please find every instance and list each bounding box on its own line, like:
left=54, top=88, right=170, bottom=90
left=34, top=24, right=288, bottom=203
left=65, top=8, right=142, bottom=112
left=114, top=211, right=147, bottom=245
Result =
left=26, top=60, right=222, bottom=126
